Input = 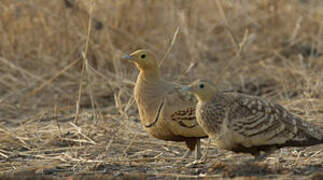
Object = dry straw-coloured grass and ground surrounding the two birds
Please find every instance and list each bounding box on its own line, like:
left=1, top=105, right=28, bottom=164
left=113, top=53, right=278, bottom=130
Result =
left=0, top=0, right=323, bottom=179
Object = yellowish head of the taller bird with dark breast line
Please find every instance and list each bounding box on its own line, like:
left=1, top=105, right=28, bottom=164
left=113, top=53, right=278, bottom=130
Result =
left=123, top=49, right=159, bottom=71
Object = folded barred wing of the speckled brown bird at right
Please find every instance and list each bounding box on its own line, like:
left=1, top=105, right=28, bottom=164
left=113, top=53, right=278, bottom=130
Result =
left=227, top=94, right=304, bottom=147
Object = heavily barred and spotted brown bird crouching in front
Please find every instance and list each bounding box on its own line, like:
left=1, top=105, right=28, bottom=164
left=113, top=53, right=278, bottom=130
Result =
left=184, top=80, right=323, bottom=154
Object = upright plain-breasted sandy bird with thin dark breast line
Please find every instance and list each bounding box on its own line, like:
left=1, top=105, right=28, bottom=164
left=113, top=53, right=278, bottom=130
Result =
left=124, top=50, right=207, bottom=160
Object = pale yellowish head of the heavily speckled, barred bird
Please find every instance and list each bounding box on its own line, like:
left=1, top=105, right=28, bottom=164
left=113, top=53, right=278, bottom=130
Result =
left=184, top=80, right=216, bottom=101
